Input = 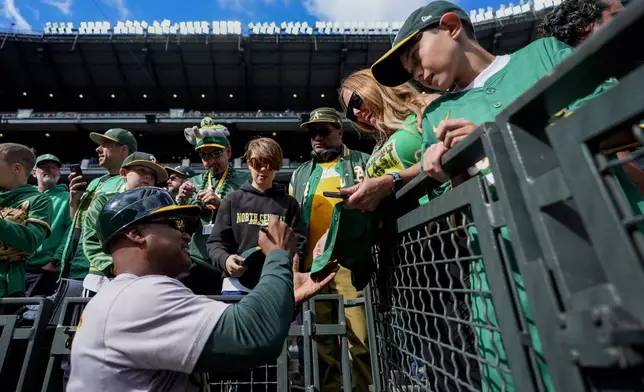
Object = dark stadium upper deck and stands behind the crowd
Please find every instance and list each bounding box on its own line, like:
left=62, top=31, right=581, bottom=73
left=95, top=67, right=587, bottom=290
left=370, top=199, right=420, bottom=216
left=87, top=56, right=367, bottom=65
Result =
left=0, top=0, right=553, bottom=178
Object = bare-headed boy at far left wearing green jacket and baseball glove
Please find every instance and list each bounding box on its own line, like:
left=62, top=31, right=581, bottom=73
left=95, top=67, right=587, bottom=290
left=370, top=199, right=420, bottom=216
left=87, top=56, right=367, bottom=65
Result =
left=0, top=143, right=53, bottom=298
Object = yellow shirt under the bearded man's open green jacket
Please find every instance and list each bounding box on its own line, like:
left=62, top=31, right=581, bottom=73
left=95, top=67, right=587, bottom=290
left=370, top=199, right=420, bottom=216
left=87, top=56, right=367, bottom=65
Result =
left=304, top=158, right=342, bottom=270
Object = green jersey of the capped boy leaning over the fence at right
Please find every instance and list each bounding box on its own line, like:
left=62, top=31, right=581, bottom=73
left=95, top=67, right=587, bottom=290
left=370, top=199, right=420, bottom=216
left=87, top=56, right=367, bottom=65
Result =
left=423, top=38, right=632, bottom=391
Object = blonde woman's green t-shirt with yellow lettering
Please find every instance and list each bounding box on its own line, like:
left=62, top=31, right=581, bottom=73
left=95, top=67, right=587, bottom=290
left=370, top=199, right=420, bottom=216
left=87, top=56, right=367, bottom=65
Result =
left=366, top=114, right=423, bottom=178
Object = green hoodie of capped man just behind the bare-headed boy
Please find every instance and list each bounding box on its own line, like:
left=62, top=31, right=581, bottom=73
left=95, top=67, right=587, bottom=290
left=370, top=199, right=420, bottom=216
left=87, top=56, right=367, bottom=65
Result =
left=27, top=184, right=72, bottom=272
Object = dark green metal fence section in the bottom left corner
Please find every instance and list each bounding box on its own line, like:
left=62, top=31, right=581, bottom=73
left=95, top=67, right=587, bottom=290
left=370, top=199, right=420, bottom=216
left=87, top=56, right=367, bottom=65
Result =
left=0, top=298, right=52, bottom=392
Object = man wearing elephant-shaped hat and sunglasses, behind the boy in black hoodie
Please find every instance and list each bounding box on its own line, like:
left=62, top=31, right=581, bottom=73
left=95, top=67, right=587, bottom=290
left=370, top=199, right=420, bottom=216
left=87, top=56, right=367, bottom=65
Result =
left=176, top=117, right=250, bottom=294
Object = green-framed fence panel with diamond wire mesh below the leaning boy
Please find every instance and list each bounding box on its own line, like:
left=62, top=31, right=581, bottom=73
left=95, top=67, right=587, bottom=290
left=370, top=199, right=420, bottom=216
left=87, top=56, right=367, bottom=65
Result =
left=367, top=128, right=551, bottom=391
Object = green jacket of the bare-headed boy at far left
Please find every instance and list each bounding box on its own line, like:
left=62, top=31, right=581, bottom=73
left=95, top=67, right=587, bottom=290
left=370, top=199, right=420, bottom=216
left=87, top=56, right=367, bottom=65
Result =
left=0, top=185, right=54, bottom=262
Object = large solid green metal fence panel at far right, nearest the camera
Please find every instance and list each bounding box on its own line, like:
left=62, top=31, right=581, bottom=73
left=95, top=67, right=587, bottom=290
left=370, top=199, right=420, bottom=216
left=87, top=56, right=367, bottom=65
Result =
left=484, top=2, right=644, bottom=392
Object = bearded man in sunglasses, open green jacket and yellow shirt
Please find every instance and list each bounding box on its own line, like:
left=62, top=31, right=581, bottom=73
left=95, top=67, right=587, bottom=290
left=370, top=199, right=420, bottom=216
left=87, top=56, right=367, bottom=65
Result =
left=289, top=108, right=371, bottom=391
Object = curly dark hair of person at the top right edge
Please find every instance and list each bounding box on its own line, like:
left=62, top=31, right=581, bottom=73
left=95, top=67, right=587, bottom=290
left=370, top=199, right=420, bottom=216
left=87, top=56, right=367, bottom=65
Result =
left=538, top=0, right=608, bottom=46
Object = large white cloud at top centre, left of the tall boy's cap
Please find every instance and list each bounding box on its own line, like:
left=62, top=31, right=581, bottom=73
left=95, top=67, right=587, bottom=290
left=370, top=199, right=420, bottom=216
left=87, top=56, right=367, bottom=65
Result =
left=303, top=0, right=436, bottom=22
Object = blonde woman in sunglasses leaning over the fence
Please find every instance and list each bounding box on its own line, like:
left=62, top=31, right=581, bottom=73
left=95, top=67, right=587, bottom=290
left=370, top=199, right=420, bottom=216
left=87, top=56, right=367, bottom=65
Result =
left=340, top=69, right=439, bottom=182
